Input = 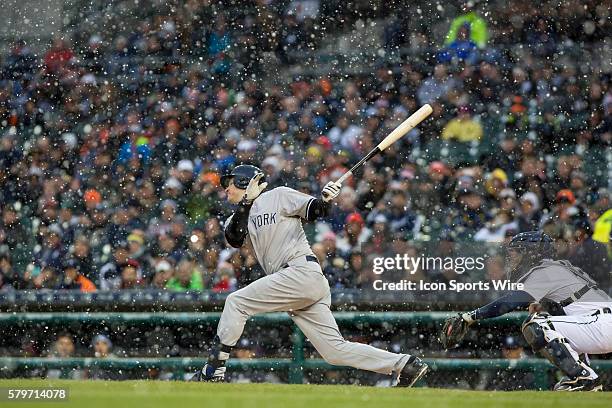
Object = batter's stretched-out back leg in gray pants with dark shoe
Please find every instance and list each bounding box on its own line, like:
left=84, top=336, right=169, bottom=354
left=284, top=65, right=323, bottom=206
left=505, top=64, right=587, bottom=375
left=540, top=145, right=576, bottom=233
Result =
left=290, top=294, right=428, bottom=386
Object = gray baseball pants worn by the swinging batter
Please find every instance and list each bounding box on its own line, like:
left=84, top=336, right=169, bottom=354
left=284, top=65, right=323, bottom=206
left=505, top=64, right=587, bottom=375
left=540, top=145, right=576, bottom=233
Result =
left=217, top=257, right=410, bottom=374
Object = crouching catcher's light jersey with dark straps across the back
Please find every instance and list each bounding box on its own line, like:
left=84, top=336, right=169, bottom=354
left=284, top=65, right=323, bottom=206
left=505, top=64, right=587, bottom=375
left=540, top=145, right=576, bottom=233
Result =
left=518, top=259, right=612, bottom=315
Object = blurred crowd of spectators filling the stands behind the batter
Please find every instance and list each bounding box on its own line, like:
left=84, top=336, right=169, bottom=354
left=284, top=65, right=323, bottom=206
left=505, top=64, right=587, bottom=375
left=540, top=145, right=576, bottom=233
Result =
left=0, top=1, right=612, bottom=292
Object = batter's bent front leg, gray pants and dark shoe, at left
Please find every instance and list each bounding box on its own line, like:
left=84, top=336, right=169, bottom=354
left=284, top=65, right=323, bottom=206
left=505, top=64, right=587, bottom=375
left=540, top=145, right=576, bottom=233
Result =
left=192, top=268, right=327, bottom=381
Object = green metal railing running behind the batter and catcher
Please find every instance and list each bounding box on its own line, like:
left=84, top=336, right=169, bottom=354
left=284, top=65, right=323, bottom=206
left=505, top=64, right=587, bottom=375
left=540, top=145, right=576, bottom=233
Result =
left=0, top=312, right=612, bottom=389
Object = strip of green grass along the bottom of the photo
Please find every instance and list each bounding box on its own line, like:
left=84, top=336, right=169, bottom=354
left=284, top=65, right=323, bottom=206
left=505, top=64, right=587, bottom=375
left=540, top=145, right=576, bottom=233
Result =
left=0, top=380, right=612, bottom=408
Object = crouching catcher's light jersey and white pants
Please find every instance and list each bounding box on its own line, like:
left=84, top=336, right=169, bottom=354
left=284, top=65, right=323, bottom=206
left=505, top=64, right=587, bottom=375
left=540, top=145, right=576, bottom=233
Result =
left=519, top=260, right=612, bottom=359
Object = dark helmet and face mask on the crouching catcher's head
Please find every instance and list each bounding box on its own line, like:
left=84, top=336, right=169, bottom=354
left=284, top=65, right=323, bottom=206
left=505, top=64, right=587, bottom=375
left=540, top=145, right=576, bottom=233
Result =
left=505, top=231, right=555, bottom=280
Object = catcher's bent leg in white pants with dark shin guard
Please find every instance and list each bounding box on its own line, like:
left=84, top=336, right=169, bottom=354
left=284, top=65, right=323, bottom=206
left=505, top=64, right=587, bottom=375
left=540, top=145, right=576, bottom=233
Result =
left=522, top=314, right=609, bottom=391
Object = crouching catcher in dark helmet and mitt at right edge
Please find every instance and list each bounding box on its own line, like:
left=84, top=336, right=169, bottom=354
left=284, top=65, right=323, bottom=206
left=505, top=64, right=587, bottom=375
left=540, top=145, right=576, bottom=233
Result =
left=440, top=231, right=612, bottom=391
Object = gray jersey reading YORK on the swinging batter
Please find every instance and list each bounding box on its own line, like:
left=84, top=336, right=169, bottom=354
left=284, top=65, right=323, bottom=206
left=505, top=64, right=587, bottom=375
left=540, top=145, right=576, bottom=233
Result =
left=227, top=187, right=314, bottom=275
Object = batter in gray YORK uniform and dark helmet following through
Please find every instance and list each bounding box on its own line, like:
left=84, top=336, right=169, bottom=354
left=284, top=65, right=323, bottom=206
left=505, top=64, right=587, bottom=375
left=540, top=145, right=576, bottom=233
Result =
left=192, top=165, right=428, bottom=387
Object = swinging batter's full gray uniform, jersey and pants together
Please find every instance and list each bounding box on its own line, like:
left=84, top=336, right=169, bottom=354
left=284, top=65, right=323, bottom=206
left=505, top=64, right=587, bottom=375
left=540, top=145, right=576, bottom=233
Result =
left=217, top=187, right=410, bottom=374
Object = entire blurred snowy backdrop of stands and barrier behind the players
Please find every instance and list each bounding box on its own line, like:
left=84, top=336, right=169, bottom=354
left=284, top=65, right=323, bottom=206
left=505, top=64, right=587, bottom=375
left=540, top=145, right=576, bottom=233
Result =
left=0, top=0, right=612, bottom=389
